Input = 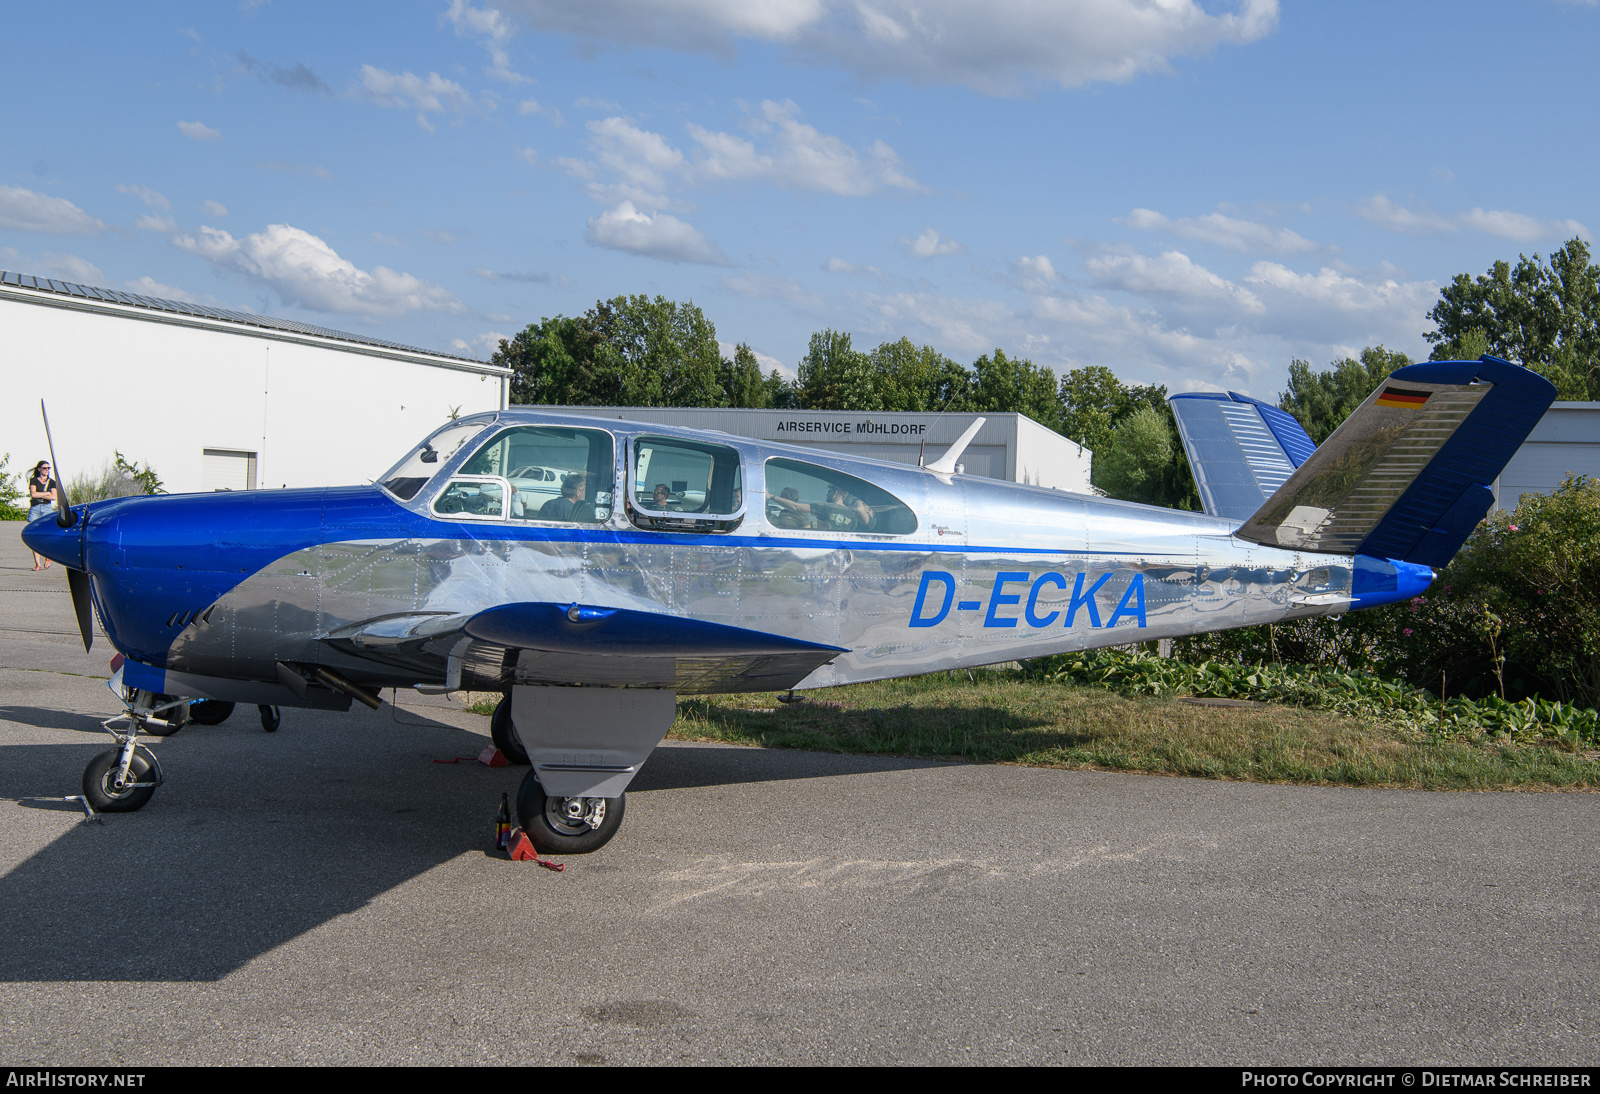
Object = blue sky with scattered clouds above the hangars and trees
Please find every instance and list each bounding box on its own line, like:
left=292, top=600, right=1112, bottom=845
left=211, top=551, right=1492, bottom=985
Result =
left=0, top=0, right=1600, bottom=397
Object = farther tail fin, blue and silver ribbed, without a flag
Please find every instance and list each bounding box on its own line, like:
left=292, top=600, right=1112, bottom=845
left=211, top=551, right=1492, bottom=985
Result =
left=1168, top=392, right=1317, bottom=520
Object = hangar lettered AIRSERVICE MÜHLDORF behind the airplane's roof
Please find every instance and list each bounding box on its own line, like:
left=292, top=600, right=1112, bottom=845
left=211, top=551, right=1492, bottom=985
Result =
left=550, top=406, right=1091, bottom=494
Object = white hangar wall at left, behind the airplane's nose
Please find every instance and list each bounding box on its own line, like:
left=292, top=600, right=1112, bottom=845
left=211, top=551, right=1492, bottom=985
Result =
left=0, top=270, right=510, bottom=494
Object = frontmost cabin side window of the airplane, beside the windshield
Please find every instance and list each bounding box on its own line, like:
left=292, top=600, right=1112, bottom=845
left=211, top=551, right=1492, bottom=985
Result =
left=461, top=425, right=614, bottom=525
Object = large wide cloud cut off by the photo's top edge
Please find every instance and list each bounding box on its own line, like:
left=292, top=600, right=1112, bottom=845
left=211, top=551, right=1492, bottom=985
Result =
left=499, top=0, right=1278, bottom=94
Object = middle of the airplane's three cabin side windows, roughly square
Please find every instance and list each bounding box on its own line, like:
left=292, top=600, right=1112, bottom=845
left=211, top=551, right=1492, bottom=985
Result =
left=627, top=437, right=744, bottom=533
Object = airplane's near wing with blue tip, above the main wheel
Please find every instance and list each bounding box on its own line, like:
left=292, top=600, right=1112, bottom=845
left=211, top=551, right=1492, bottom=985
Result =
left=322, top=603, right=846, bottom=694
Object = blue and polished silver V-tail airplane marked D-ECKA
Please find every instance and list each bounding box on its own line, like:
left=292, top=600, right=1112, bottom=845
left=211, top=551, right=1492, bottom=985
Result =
left=22, top=357, right=1555, bottom=854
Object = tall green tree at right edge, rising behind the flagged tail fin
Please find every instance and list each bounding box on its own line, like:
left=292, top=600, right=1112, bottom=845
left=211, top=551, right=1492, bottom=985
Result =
left=1422, top=238, right=1600, bottom=400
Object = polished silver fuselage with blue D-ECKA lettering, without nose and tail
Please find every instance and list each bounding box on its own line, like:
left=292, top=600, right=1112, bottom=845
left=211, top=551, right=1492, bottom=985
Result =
left=140, top=408, right=1352, bottom=693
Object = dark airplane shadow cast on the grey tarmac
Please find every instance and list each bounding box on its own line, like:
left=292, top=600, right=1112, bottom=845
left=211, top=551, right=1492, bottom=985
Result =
left=0, top=707, right=930, bottom=982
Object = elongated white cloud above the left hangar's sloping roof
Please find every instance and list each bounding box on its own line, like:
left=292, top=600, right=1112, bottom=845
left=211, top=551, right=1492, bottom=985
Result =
left=173, top=224, right=466, bottom=317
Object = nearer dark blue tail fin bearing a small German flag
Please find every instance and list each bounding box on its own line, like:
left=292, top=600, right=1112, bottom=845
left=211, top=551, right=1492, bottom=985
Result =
left=1234, top=357, right=1555, bottom=568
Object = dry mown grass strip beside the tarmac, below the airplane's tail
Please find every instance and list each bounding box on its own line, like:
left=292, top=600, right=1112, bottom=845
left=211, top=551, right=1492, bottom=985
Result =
left=472, top=670, right=1600, bottom=790
